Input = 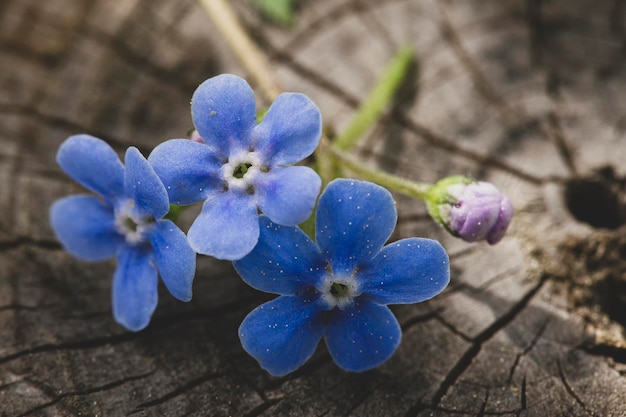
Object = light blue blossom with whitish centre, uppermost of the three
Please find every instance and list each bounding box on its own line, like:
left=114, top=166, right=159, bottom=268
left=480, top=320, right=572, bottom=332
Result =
left=148, top=74, right=321, bottom=260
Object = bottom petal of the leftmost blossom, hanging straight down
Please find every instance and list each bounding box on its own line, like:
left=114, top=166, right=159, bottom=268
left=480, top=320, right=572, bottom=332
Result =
left=112, top=246, right=158, bottom=331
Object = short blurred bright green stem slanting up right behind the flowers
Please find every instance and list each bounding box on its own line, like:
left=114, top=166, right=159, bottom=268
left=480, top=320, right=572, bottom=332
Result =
left=333, top=46, right=414, bottom=151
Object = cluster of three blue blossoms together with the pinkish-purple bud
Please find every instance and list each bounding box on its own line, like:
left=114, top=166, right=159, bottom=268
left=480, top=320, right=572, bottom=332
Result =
left=50, top=75, right=512, bottom=375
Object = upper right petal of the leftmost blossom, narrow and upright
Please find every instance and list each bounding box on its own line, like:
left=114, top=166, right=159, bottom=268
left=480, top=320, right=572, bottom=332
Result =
left=124, top=146, right=170, bottom=219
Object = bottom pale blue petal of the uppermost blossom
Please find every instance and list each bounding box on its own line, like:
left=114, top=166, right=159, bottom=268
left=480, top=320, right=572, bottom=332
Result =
left=187, top=191, right=259, bottom=261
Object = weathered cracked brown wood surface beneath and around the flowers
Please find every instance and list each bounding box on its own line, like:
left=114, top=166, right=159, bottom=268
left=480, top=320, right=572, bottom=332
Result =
left=0, top=0, right=626, bottom=417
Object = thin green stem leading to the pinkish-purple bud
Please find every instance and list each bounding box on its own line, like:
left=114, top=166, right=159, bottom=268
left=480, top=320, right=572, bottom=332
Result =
left=320, top=141, right=432, bottom=201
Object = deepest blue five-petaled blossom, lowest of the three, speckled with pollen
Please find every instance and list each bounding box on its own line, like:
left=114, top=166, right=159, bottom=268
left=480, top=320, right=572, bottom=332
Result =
left=233, top=179, right=450, bottom=375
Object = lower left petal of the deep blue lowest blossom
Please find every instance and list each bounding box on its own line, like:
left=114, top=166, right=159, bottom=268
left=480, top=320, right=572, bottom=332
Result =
left=239, top=296, right=324, bottom=376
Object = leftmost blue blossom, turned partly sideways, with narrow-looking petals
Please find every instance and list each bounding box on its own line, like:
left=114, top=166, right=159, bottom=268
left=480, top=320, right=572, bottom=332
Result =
left=50, top=135, right=196, bottom=331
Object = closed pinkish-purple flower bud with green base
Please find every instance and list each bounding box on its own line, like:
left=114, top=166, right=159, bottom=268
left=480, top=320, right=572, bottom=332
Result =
left=427, top=176, right=513, bottom=245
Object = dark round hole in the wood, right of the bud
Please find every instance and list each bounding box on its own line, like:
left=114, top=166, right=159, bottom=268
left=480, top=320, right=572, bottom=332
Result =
left=565, top=167, right=626, bottom=229
